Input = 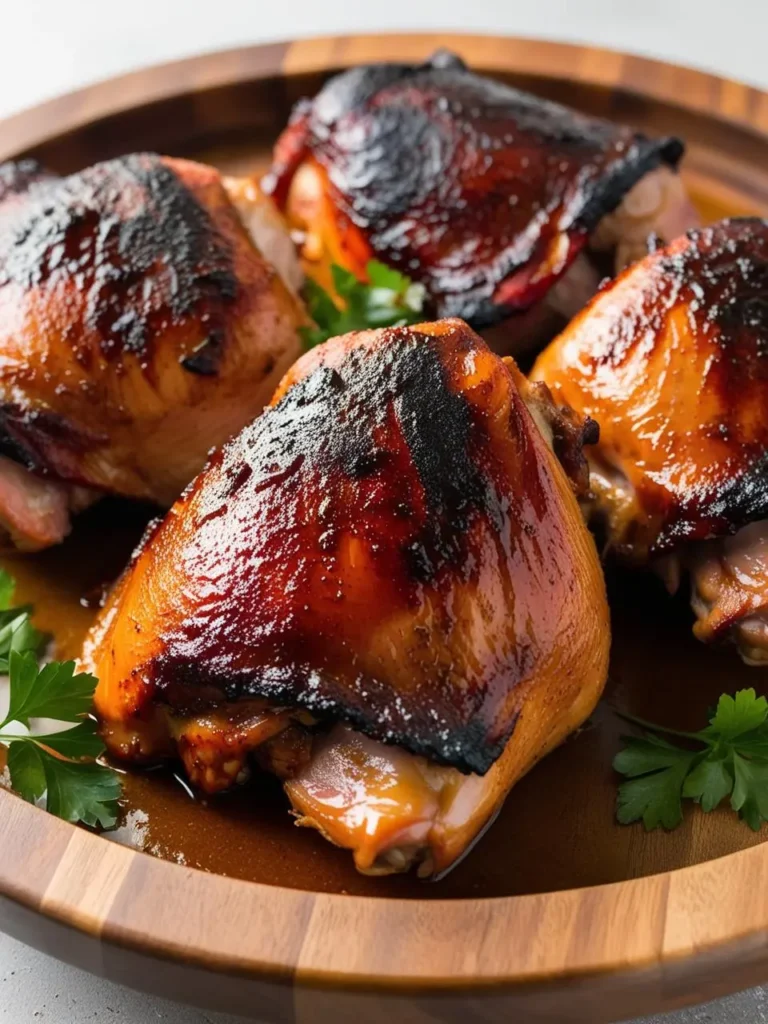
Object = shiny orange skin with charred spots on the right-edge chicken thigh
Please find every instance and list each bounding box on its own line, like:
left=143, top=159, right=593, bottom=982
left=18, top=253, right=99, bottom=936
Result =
left=534, top=218, right=768, bottom=559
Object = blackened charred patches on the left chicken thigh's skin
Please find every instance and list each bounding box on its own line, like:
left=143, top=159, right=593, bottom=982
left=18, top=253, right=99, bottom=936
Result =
left=0, top=154, right=240, bottom=484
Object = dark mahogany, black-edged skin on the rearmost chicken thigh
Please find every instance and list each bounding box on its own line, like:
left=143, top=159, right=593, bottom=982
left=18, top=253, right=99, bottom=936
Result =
left=265, top=52, right=682, bottom=325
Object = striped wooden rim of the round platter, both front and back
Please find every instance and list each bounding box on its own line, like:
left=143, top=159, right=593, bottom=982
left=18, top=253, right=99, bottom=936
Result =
left=0, top=33, right=768, bottom=1007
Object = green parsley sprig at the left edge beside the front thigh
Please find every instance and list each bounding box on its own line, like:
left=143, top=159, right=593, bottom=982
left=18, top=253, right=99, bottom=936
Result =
left=0, top=569, right=121, bottom=828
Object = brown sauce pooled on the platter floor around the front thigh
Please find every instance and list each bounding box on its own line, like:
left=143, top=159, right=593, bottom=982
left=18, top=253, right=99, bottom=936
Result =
left=2, top=501, right=768, bottom=899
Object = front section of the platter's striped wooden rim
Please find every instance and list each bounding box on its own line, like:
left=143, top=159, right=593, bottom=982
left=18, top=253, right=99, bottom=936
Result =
left=0, top=790, right=768, bottom=991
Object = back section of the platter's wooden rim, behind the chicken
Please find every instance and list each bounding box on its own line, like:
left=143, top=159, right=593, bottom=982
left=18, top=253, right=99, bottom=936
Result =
left=0, top=32, right=768, bottom=160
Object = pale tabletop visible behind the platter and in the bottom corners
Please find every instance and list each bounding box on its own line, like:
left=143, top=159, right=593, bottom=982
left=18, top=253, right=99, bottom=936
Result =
left=0, top=0, right=768, bottom=1024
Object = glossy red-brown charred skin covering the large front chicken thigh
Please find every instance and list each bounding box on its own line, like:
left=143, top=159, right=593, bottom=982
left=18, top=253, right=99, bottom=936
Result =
left=84, top=321, right=608, bottom=772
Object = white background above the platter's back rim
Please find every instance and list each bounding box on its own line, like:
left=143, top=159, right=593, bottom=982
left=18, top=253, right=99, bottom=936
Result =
left=0, top=0, right=768, bottom=117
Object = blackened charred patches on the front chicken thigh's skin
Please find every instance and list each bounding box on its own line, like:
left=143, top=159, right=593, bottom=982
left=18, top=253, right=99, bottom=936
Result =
left=160, top=332, right=506, bottom=757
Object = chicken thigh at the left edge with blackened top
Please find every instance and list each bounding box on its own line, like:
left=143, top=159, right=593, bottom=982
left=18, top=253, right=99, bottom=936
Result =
left=0, top=154, right=303, bottom=548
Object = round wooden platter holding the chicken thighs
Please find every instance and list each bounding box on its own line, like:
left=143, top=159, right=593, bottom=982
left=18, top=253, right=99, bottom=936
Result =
left=0, top=35, right=768, bottom=1024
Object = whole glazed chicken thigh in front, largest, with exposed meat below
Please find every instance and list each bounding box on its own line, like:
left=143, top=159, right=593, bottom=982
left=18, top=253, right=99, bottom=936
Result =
left=83, top=319, right=609, bottom=874
